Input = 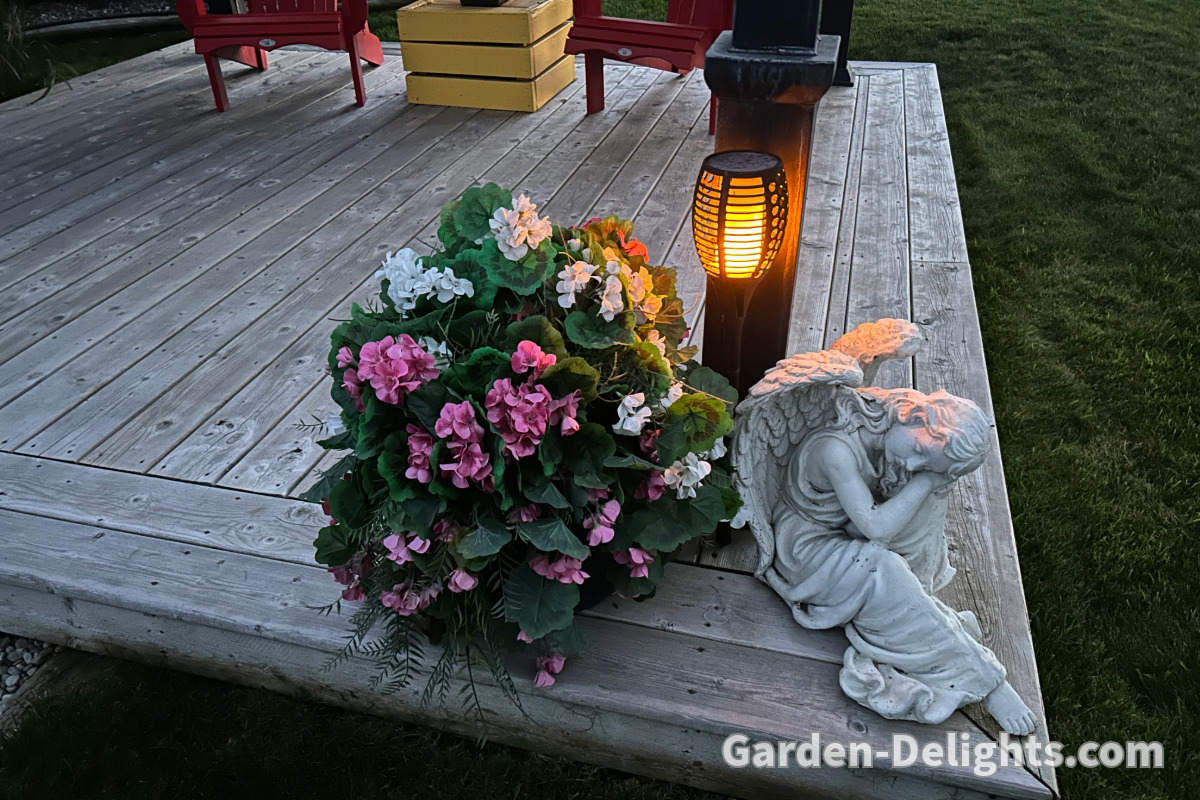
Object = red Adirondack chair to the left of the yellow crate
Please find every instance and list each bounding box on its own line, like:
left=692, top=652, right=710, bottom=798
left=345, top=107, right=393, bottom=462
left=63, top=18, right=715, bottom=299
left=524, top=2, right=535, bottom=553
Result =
left=175, top=0, right=383, bottom=112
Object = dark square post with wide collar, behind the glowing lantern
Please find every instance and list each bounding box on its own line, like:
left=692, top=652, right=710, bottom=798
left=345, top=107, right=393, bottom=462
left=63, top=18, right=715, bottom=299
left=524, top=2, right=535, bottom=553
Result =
left=702, top=0, right=839, bottom=400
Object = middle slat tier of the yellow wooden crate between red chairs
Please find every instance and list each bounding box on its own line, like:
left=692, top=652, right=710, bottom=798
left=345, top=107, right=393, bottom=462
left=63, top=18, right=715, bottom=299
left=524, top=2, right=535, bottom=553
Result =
left=400, top=23, right=571, bottom=80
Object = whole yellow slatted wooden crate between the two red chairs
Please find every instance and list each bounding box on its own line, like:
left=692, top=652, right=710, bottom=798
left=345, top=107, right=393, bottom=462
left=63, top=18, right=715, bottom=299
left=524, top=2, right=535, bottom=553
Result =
left=396, top=0, right=575, bottom=112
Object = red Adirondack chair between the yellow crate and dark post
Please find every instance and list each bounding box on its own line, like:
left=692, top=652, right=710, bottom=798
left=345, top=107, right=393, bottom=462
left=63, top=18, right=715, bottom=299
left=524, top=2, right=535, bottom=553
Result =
left=566, top=0, right=733, bottom=133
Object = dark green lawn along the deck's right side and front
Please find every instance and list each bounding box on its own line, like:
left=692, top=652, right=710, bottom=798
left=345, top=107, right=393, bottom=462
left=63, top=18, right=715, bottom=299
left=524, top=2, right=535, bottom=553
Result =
left=0, top=0, right=1200, bottom=800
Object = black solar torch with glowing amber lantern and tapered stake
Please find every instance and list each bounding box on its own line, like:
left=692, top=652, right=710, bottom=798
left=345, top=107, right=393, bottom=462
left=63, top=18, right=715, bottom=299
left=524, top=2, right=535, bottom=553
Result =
left=691, top=150, right=787, bottom=397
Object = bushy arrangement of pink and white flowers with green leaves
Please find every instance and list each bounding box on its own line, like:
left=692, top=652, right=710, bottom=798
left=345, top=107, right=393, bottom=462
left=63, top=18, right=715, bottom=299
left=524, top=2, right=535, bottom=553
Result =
left=306, top=184, right=740, bottom=706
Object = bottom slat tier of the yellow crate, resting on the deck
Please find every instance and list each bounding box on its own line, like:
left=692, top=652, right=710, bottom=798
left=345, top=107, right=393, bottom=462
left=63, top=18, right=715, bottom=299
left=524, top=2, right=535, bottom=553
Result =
left=406, top=55, right=575, bottom=112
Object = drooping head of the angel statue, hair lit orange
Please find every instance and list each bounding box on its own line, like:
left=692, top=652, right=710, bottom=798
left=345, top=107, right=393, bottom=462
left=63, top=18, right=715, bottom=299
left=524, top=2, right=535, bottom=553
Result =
left=858, top=387, right=991, bottom=480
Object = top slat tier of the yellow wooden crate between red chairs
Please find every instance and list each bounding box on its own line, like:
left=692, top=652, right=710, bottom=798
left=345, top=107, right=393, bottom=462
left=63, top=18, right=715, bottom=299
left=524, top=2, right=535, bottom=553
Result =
left=396, top=0, right=571, bottom=46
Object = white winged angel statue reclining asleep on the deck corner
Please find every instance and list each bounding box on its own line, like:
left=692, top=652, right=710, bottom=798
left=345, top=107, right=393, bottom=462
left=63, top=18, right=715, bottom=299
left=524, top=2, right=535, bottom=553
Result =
left=733, top=319, right=1034, bottom=735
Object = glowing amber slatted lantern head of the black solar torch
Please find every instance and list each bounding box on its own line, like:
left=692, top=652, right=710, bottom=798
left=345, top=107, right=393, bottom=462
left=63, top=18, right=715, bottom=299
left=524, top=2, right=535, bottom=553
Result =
left=691, top=150, right=787, bottom=281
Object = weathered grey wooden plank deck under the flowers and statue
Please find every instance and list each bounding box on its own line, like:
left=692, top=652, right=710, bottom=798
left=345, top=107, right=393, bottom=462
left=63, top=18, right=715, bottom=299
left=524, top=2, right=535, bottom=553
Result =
left=0, top=44, right=1055, bottom=799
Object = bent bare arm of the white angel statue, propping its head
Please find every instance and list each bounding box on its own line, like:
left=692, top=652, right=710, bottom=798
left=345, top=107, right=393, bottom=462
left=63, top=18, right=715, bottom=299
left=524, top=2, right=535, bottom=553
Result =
left=816, top=439, right=941, bottom=545
